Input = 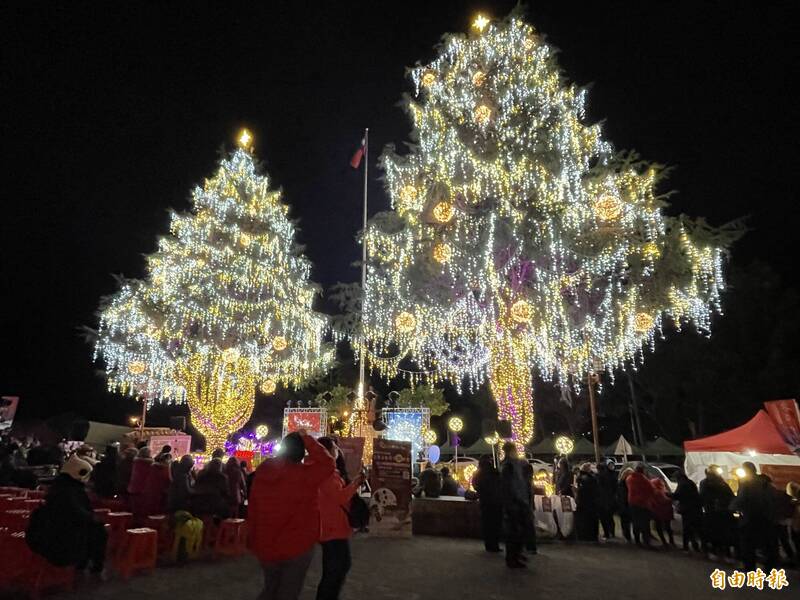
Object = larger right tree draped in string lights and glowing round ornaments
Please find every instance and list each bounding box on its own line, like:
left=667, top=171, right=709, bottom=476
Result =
left=357, top=16, right=736, bottom=443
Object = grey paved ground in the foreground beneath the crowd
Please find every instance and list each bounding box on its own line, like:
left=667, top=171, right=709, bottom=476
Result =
left=36, top=537, right=800, bottom=600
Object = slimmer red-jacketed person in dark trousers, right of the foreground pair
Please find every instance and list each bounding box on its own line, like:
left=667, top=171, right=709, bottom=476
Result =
left=317, top=437, right=364, bottom=600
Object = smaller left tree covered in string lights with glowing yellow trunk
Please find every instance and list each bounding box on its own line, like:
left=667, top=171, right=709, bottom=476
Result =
left=95, top=131, right=333, bottom=449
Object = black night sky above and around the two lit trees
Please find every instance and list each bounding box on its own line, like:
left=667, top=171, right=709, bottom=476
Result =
left=0, top=0, right=800, bottom=428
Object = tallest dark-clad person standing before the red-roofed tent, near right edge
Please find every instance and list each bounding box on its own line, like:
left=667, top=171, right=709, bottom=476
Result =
left=731, top=462, right=778, bottom=573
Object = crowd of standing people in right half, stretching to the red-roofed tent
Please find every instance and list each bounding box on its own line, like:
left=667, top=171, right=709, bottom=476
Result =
left=473, top=444, right=800, bottom=571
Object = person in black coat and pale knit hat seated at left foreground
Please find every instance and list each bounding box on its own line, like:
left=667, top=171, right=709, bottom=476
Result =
left=26, top=455, right=108, bottom=575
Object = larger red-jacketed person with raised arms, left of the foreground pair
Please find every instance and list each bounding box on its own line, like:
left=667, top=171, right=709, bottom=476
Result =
left=252, top=431, right=336, bottom=600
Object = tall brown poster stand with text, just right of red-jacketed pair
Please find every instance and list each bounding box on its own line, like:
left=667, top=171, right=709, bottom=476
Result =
left=369, top=438, right=411, bottom=537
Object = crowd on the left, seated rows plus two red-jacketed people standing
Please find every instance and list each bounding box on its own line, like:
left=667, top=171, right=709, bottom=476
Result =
left=2, top=432, right=364, bottom=600
